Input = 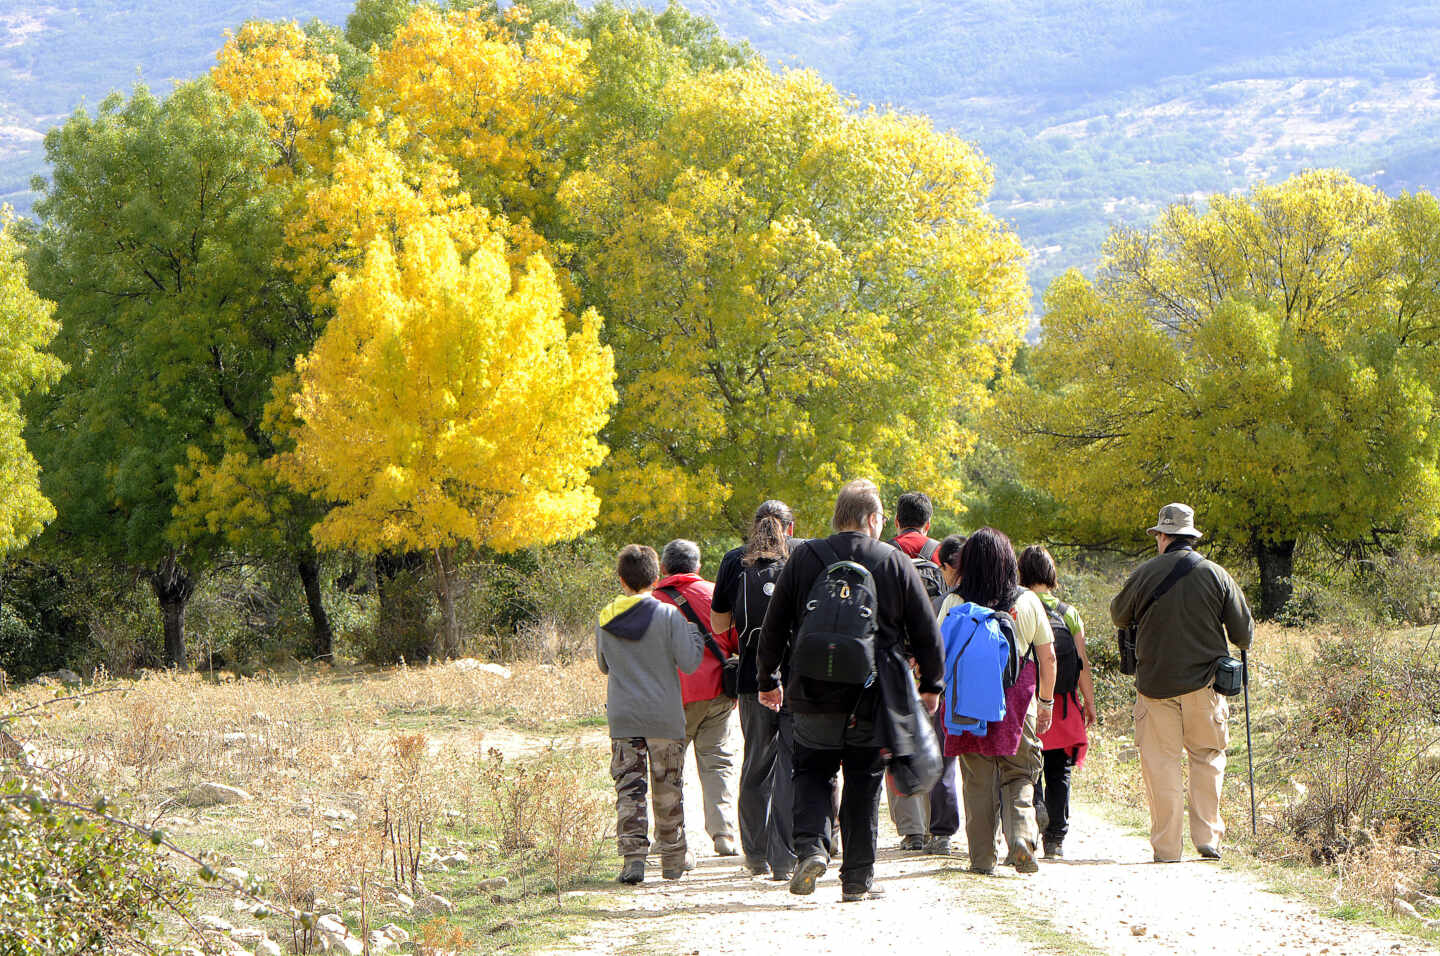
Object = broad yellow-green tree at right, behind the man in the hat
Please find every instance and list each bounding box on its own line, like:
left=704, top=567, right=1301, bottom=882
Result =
left=991, top=171, right=1440, bottom=615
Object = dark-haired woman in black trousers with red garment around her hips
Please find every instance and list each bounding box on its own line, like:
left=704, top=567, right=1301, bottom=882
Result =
left=1020, top=544, right=1094, bottom=860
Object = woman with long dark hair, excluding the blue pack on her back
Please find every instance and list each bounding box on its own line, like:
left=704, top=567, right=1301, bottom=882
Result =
left=942, top=528, right=1056, bottom=872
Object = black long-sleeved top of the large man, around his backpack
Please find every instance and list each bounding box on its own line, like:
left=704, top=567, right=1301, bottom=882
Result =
left=756, top=531, right=945, bottom=714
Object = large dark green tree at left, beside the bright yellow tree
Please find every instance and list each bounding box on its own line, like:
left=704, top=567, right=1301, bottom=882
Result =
left=32, top=82, right=328, bottom=667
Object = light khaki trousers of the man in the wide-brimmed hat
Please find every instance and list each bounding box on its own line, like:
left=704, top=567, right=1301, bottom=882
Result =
left=1135, top=687, right=1230, bottom=862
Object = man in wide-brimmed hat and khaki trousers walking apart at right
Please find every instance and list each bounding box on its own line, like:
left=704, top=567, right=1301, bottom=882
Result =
left=1110, top=502, right=1254, bottom=862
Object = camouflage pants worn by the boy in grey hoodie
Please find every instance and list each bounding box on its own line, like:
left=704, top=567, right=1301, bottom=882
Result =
left=611, top=737, right=685, bottom=867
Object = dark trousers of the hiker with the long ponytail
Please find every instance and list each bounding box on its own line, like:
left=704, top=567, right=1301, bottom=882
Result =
left=739, top=694, right=795, bottom=874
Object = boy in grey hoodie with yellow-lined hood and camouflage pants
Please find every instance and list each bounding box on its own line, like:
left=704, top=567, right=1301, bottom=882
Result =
left=595, top=544, right=704, bottom=883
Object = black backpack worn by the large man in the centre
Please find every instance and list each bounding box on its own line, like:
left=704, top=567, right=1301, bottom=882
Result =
left=791, top=540, right=876, bottom=687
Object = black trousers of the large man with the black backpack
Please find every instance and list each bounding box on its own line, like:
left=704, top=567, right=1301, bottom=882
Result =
left=793, top=741, right=886, bottom=888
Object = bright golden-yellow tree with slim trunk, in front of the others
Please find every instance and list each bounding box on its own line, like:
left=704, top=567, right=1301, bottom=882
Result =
left=279, top=220, right=615, bottom=655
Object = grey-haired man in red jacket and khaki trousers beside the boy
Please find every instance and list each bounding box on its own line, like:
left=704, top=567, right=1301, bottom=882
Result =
left=652, top=538, right=739, bottom=857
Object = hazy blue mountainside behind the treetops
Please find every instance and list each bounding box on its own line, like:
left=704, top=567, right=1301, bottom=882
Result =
left=0, top=0, right=1440, bottom=299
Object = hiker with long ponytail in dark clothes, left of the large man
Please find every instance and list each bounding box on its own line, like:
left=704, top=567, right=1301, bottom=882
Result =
left=710, top=500, right=795, bottom=881
